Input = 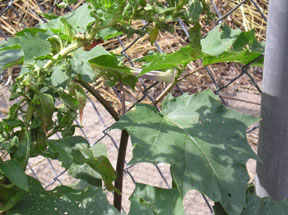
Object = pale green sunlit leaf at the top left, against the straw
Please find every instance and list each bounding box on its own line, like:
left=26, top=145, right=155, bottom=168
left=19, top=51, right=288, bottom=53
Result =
left=63, top=4, right=95, bottom=33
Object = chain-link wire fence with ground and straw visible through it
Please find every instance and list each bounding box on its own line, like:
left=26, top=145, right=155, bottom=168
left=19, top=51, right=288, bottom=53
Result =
left=0, top=0, right=267, bottom=214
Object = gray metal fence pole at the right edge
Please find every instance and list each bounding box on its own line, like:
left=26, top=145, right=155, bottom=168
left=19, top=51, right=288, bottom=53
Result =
left=256, top=0, right=288, bottom=200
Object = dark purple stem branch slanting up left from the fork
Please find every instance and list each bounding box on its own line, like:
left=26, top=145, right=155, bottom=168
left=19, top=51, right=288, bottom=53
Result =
left=76, top=80, right=119, bottom=121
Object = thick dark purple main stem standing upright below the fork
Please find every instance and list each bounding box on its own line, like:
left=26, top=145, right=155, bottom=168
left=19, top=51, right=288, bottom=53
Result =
left=114, top=130, right=129, bottom=212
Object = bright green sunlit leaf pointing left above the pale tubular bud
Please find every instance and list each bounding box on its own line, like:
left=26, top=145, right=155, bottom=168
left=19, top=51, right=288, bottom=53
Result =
left=139, top=46, right=199, bottom=76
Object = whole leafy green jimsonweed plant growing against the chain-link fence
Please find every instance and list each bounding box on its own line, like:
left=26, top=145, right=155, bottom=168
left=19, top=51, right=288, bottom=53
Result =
left=0, top=0, right=287, bottom=215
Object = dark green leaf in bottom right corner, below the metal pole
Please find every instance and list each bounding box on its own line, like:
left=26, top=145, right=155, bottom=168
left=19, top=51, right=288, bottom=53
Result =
left=241, top=196, right=288, bottom=215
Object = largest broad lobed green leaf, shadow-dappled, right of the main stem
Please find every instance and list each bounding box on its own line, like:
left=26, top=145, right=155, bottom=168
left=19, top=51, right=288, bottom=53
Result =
left=111, top=90, right=258, bottom=214
